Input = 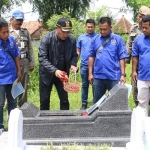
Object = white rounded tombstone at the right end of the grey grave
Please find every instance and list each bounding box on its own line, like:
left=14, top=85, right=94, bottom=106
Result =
left=126, top=107, right=145, bottom=150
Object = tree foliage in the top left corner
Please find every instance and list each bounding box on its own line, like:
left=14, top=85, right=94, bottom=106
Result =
left=0, top=0, right=26, bottom=18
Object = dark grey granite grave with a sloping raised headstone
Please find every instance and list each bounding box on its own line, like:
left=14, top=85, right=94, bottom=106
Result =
left=21, top=84, right=132, bottom=147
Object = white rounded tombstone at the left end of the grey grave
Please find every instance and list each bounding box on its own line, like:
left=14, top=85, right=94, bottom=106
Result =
left=6, top=108, right=26, bottom=150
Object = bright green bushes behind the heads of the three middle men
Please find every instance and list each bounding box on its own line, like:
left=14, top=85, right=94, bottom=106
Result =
left=46, top=6, right=114, bottom=39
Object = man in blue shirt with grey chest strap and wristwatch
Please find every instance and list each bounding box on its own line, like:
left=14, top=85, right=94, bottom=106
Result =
left=89, top=17, right=128, bottom=103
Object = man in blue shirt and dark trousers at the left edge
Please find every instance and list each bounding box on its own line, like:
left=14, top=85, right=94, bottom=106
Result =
left=0, top=19, right=21, bottom=134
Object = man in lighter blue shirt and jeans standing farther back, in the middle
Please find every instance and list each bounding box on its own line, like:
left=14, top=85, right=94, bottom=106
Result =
left=77, top=19, right=96, bottom=109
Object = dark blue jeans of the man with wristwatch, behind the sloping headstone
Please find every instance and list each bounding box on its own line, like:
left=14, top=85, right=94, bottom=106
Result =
left=93, top=79, right=119, bottom=104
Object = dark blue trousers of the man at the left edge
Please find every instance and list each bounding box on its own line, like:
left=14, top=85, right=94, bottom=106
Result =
left=0, top=84, right=17, bottom=129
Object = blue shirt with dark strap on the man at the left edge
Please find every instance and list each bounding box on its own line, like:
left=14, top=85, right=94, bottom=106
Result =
left=0, top=36, right=20, bottom=85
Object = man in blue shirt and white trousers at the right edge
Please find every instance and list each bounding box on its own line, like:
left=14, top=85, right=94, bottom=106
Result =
left=132, top=14, right=150, bottom=116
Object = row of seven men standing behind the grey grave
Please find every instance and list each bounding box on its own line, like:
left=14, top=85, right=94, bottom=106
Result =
left=0, top=6, right=150, bottom=132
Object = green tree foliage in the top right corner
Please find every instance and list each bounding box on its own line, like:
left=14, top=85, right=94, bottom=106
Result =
left=122, top=0, right=150, bottom=21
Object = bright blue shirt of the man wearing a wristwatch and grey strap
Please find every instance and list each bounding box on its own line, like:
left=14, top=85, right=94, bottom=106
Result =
left=89, top=31, right=128, bottom=80
